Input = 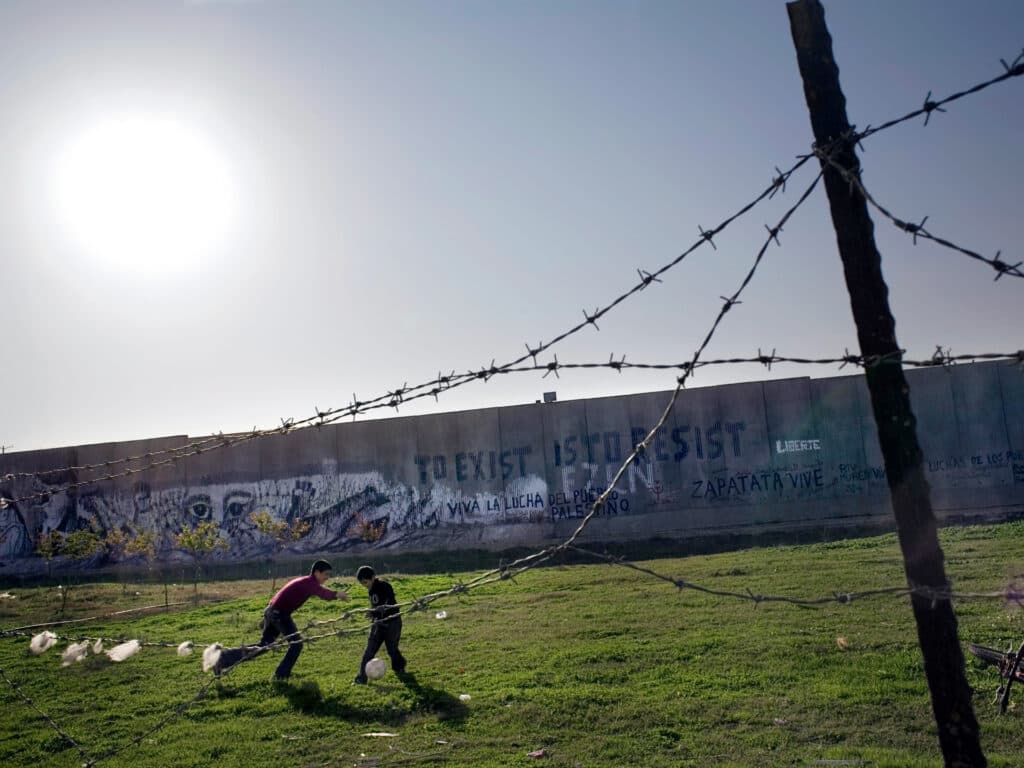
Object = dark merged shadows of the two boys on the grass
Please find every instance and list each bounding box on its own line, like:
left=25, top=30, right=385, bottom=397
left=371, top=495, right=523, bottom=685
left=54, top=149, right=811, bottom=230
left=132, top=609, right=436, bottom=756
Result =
left=278, top=673, right=469, bottom=725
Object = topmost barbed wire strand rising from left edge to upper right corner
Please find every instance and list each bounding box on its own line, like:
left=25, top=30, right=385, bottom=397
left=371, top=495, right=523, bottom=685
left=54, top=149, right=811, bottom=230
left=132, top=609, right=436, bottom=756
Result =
left=0, top=51, right=1024, bottom=501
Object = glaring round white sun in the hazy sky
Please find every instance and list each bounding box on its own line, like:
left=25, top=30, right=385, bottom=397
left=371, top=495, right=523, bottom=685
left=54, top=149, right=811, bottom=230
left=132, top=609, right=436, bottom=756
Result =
left=56, top=115, right=234, bottom=273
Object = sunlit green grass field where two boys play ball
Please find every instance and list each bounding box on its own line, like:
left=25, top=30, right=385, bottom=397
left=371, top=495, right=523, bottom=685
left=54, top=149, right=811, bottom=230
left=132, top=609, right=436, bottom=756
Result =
left=0, top=523, right=1024, bottom=768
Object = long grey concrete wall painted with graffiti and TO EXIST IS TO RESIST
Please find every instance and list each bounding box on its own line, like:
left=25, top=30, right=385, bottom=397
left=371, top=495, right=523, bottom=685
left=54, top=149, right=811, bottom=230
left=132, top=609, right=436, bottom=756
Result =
left=0, top=361, right=1024, bottom=569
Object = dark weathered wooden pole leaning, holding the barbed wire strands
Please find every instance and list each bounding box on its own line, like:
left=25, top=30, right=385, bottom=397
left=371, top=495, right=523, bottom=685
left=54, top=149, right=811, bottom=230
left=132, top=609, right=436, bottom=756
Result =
left=786, top=0, right=986, bottom=767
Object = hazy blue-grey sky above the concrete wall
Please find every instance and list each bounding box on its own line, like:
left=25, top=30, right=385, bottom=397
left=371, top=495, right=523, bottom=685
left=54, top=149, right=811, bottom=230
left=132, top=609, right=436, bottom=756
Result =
left=0, top=0, right=1024, bottom=451
